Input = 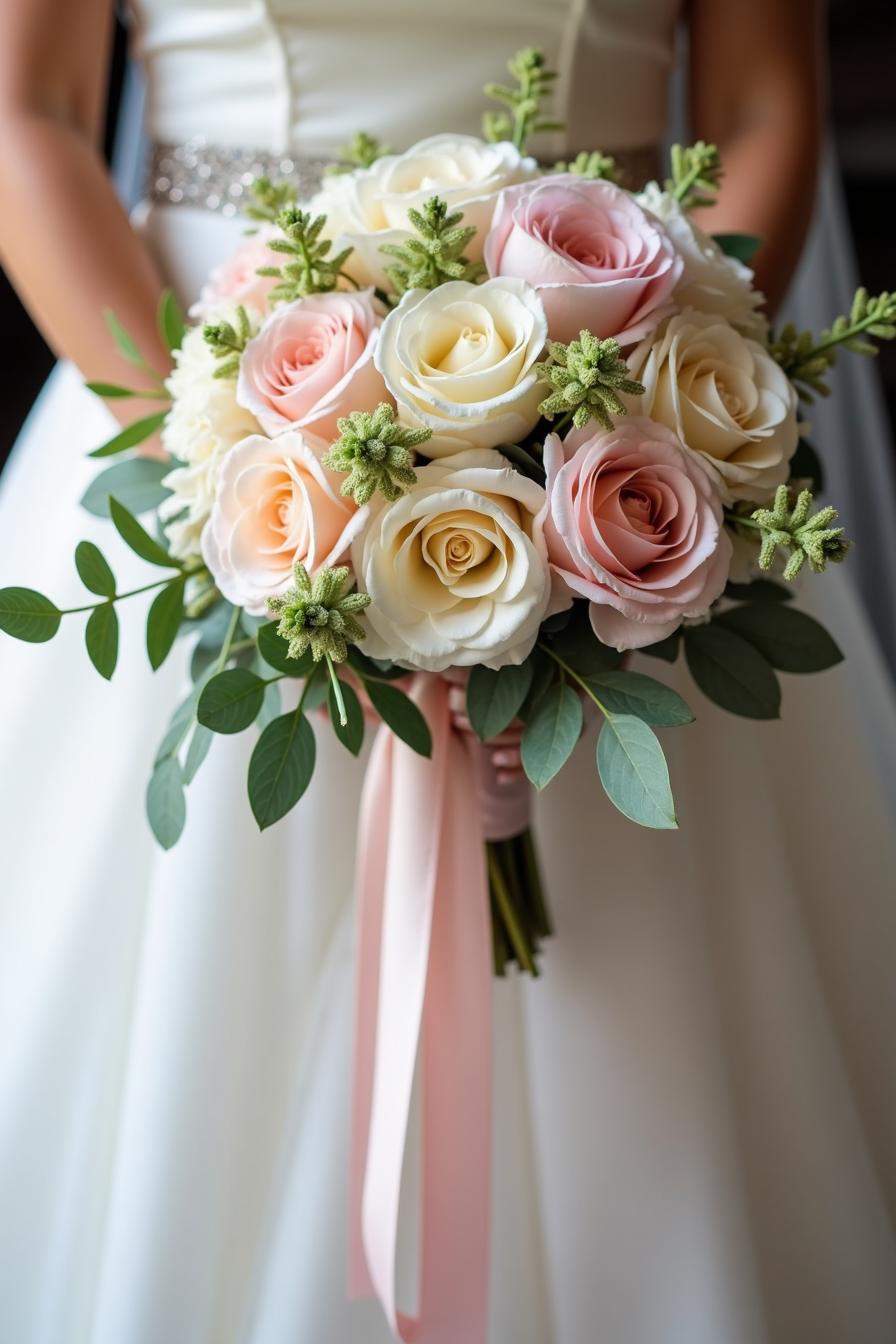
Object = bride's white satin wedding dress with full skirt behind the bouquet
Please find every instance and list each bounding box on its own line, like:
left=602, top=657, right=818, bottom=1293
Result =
left=0, top=0, right=896, bottom=1344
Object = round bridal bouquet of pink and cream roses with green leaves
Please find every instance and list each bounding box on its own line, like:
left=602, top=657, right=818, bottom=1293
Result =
left=0, top=51, right=896, bottom=972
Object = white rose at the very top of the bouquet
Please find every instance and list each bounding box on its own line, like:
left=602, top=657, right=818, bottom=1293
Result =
left=309, top=134, right=540, bottom=289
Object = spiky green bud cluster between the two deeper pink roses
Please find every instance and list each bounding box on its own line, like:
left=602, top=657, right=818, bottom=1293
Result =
left=536, top=331, right=643, bottom=430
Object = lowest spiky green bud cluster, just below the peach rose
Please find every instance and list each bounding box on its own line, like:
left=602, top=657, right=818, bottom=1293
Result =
left=267, top=564, right=371, bottom=663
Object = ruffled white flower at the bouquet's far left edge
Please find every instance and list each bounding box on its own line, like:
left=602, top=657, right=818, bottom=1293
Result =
left=159, top=310, right=261, bottom=560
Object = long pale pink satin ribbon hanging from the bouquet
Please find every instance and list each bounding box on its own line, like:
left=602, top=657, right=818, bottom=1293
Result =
left=349, top=673, right=528, bottom=1344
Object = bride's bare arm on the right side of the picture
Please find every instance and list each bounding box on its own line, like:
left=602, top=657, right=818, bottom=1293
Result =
left=689, top=0, right=821, bottom=310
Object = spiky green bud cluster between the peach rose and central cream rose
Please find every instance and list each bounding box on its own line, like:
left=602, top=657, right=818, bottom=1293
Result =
left=324, top=402, right=433, bottom=504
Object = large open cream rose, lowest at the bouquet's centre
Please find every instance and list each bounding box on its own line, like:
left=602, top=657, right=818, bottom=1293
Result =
left=352, top=449, right=551, bottom=672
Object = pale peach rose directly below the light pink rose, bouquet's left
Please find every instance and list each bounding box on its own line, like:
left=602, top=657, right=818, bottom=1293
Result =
left=201, top=430, right=365, bottom=616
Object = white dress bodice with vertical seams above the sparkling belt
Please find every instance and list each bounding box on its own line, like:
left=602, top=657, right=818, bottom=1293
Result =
left=132, top=0, right=680, bottom=155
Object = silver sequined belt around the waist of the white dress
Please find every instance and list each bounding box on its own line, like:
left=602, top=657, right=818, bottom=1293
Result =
left=145, top=136, right=658, bottom=215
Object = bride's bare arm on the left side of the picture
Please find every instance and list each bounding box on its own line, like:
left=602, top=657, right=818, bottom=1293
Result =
left=0, top=0, right=169, bottom=419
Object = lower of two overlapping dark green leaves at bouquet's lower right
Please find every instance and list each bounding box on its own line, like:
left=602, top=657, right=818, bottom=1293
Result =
left=684, top=621, right=780, bottom=719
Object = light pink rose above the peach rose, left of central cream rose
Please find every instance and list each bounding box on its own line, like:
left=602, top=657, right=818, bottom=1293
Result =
left=236, top=289, right=390, bottom=442
